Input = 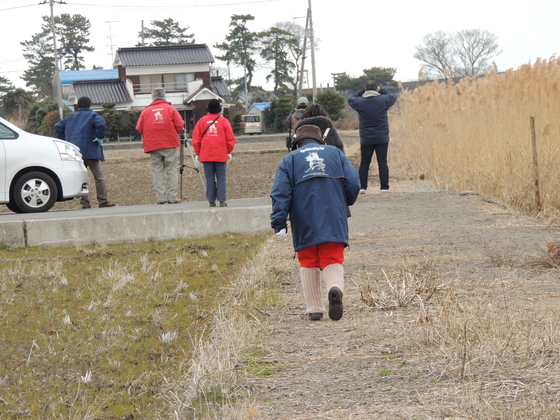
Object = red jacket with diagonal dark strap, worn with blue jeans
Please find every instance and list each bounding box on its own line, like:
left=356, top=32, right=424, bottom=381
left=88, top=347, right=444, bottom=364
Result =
left=192, top=113, right=235, bottom=162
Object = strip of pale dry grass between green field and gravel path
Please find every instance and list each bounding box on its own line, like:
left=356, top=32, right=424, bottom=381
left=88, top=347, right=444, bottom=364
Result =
left=170, top=240, right=279, bottom=419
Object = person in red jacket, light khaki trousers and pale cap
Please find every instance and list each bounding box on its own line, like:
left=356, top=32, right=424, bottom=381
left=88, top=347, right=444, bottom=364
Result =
left=136, top=88, right=184, bottom=204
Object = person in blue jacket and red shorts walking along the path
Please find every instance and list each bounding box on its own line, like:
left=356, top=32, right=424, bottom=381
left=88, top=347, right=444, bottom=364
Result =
left=270, top=125, right=360, bottom=321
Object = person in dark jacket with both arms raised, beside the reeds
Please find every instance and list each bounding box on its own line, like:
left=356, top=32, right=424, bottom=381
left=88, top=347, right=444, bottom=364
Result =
left=348, top=80, right=397, bottom=194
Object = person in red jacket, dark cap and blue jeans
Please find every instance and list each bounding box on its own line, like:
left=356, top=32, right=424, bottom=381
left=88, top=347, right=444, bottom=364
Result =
left=192, top=99, right=235, bottom=207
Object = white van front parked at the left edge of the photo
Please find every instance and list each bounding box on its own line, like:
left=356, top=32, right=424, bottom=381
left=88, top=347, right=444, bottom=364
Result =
left=0, top=117, right=88, bottom=213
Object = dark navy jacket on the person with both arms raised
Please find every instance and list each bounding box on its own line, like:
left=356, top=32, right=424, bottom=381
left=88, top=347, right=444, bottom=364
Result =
left=348, top=89, right=397, bottom=145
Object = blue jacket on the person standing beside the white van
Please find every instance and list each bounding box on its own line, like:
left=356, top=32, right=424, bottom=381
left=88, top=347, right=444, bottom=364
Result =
left=54, top=108, right=106, bottom=162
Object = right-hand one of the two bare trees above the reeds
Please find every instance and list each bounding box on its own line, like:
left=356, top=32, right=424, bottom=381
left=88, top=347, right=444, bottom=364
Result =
left=454, top=29, right=502, bottom=76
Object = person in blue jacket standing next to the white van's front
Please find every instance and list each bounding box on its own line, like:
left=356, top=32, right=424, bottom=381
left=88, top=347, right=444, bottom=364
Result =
left=54, top=96, right=116, bottom=209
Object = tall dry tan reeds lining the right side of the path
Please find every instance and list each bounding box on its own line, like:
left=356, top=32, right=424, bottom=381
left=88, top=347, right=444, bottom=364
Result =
left=390, top=58, right=560, bottom=223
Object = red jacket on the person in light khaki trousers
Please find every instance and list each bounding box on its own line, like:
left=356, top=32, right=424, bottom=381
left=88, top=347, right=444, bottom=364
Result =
left=136, top=99, right=184, bottom=153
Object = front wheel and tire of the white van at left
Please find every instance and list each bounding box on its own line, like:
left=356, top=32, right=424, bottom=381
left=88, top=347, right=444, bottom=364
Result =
left=12, top=171, right=58, bottom=213
